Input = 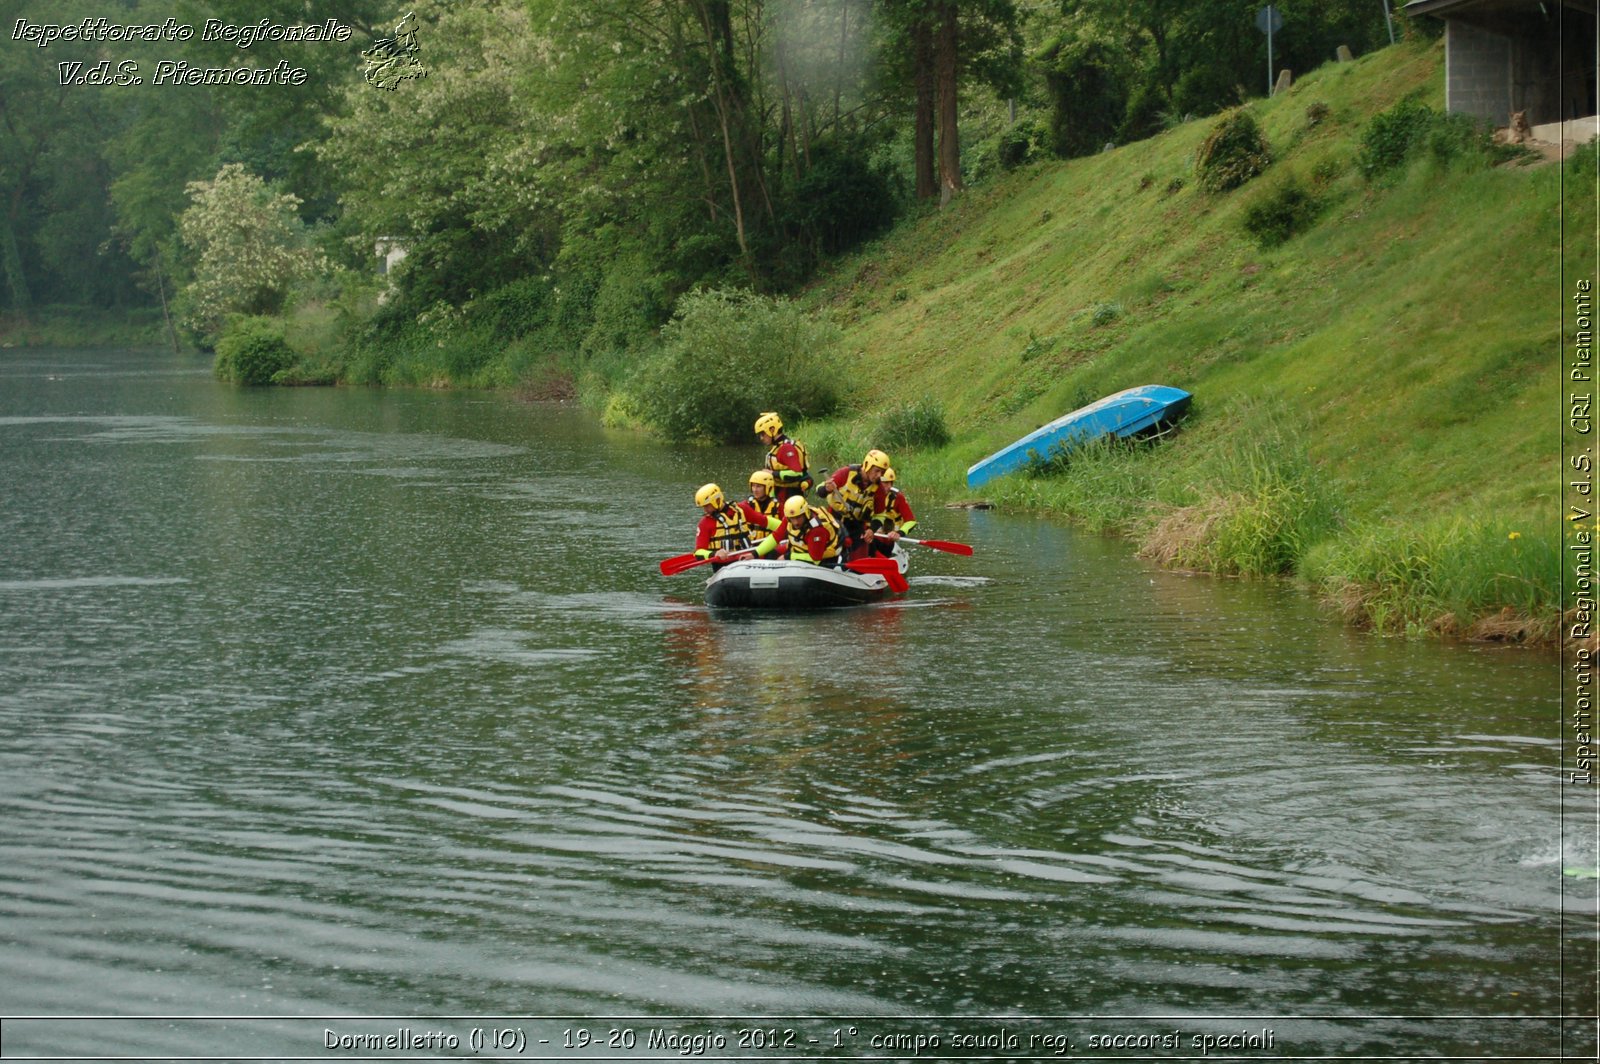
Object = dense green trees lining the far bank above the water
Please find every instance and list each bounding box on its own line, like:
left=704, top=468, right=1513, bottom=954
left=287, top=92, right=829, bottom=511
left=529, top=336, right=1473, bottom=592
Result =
left=0, top=0, right=1414, bottom=390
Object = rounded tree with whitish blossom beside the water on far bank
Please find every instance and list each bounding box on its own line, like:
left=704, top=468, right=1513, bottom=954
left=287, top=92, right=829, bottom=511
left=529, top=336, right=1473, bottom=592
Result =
left=178, top=163, right=325, bottom=338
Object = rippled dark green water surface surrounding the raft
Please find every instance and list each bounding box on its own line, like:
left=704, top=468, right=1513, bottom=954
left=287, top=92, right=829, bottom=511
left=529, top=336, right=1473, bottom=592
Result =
left=0, top=350, right=1595, bottom=1059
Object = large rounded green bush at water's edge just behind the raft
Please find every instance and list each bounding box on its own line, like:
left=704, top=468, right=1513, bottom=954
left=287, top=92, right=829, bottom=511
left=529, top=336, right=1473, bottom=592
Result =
left=627, top=288, right=840, bottom=443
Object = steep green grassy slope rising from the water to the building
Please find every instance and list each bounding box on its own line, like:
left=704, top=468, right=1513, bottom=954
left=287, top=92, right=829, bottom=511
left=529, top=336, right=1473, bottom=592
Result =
left=810, top=43, right=1595, bottom=638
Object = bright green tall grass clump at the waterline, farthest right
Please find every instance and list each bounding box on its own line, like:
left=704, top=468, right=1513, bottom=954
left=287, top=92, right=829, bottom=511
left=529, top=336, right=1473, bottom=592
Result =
left=1302, top=515, right=1562, bottom=643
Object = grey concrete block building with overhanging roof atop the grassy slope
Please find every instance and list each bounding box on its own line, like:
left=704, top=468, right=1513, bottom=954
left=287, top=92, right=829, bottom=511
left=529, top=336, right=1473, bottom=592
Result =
left=1405, top=0, right=1600, bottom=144
